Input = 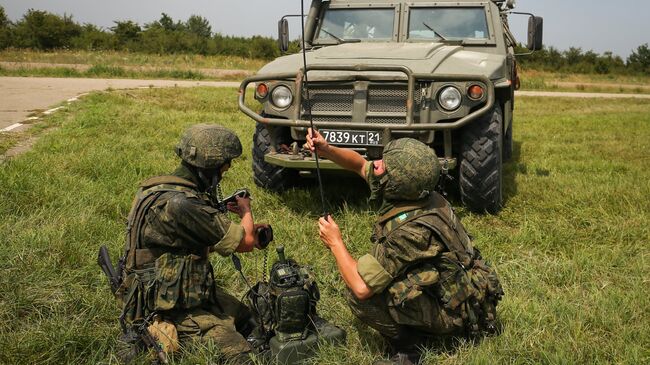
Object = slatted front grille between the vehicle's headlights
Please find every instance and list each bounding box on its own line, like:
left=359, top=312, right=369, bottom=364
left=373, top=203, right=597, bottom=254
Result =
left=301, top=82, right=421, bottom=124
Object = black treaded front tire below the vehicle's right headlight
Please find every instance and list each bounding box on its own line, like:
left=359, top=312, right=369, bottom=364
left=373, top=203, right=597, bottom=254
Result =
left=459, top=104, right=503, bottom=214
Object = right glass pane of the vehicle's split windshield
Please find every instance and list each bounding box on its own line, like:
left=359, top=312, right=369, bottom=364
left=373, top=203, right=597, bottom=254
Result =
left=408, top=7, right=490, bottom=40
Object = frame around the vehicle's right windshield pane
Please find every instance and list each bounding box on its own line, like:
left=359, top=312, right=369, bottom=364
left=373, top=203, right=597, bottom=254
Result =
left=399, top=1, right=497, bottom=46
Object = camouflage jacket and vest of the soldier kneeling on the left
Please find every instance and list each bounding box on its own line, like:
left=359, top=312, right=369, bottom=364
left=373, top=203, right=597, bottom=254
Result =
left=118, top=168, right=244, bottom=321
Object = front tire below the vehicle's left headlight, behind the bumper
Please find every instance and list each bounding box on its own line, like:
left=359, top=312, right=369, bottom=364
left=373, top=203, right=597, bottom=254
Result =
left=253, top=123, right=298, bottom=191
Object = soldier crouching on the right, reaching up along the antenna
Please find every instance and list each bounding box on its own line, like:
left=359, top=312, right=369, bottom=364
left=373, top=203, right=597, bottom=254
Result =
left=306, top=130, right=503, bottom=364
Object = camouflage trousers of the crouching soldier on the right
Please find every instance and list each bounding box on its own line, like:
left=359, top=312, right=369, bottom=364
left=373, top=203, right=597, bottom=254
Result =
left=347, top=291, right=463, bottom=348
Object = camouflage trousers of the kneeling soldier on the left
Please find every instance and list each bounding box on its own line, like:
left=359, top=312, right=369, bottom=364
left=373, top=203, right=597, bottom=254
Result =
left=160, top=287, right=252, bottom=364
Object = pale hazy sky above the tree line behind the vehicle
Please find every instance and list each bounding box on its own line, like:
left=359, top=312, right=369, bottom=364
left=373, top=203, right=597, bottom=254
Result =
left=0, top=0, right=650, bottom=59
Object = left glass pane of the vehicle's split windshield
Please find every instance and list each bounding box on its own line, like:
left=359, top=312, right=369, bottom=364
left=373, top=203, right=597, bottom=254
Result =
left=316, top=8, right=395, bottom=42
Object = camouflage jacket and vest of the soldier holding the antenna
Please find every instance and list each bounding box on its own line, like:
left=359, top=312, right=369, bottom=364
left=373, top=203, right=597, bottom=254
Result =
left=357, top=193, right=503, bottom=332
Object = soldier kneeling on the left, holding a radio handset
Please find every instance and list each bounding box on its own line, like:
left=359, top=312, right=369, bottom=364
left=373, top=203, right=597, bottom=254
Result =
left=117, top=124, right=265, bottom=364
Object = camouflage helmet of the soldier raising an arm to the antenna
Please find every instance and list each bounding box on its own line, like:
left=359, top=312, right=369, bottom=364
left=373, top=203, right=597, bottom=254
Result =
left=383, top=138, right=440, bottom=201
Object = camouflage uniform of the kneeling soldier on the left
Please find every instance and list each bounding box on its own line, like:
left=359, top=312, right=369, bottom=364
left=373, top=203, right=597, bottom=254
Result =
left=117, top=124, right=251, bottom=358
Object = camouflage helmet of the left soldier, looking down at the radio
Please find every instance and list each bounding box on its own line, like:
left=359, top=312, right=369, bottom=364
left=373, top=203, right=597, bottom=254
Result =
left=176, top=124, right=242, bottom=169
